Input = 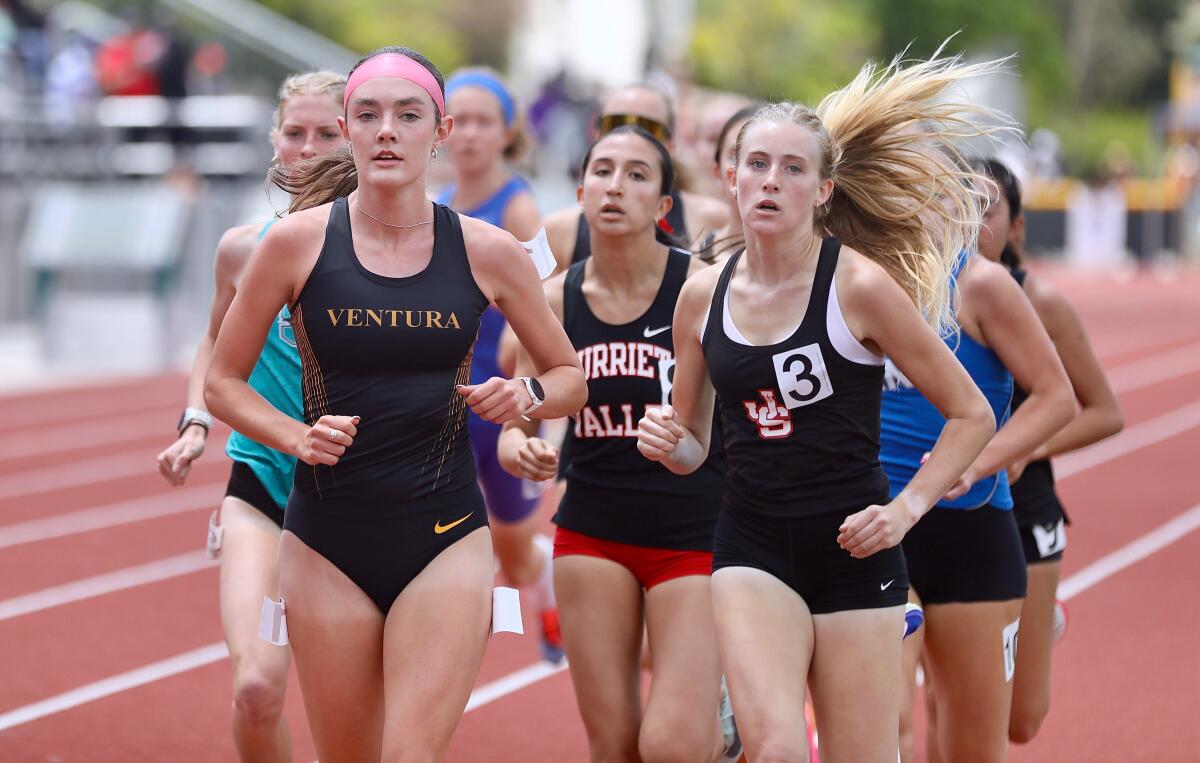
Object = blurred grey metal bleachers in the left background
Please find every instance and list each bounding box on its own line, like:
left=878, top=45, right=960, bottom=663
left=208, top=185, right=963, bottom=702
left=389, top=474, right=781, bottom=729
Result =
left=0, top=0, right=354, bottom=372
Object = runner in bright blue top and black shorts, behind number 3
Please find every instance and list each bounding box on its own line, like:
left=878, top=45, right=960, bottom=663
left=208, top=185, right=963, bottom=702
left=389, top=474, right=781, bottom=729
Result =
left=880, top=164, right=1074, bottom=761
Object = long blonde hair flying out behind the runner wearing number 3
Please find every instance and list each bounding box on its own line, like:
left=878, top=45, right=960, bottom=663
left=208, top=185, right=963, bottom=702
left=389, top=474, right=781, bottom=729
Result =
left=734, top=43, right=1014, bottom=332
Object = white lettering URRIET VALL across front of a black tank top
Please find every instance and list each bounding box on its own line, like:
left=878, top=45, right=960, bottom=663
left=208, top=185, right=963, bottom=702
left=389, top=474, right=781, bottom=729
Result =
left=575, top=342, right=674, bottom=438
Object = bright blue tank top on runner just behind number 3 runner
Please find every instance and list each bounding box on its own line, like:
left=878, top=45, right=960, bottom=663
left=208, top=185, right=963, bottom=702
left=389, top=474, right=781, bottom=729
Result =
left=880, top=258, right=1013, bottom=511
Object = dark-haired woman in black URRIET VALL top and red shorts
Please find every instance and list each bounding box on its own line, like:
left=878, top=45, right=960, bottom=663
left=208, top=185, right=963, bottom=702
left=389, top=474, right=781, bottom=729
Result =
left=500, top=126, right=725, bottom=762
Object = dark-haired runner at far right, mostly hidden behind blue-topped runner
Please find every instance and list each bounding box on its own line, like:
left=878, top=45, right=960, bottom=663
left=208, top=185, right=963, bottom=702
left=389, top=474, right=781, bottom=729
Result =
left=973, top=160, right=1124, bottom=744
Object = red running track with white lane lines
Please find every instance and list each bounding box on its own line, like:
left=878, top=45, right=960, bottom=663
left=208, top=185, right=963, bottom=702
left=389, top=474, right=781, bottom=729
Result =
left=0, top=270, right=1200, bottom=763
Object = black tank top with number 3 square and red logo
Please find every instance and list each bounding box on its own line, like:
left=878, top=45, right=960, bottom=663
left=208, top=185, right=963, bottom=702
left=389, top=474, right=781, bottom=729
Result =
left=703, top=239, right=888, bottom=518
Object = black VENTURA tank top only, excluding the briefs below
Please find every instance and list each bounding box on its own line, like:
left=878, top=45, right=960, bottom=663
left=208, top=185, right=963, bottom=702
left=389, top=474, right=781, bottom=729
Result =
left=292, top=198, right=488, bottom=506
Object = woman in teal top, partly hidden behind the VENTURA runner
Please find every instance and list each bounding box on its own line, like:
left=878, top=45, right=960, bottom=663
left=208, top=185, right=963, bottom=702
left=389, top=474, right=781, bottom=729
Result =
left=158, top=72, right=346, bottom=761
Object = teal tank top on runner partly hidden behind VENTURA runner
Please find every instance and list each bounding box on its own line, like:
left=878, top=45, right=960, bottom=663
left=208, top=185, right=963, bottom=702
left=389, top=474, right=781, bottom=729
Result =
left=226, top=220, right=304, bottom=510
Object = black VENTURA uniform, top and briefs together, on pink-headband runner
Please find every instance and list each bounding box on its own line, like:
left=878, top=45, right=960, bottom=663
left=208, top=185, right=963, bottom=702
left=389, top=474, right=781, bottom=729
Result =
left=284, top=198, right=487, bottom=613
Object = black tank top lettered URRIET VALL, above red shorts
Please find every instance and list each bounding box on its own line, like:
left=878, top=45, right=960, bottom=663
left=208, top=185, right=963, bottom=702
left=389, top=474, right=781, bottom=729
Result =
left=554, top=250, right=725, bottom=551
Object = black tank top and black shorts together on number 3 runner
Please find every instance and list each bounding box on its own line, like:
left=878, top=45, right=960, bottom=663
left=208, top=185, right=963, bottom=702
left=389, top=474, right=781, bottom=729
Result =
left=703, top=239, right=908, bottom=604
